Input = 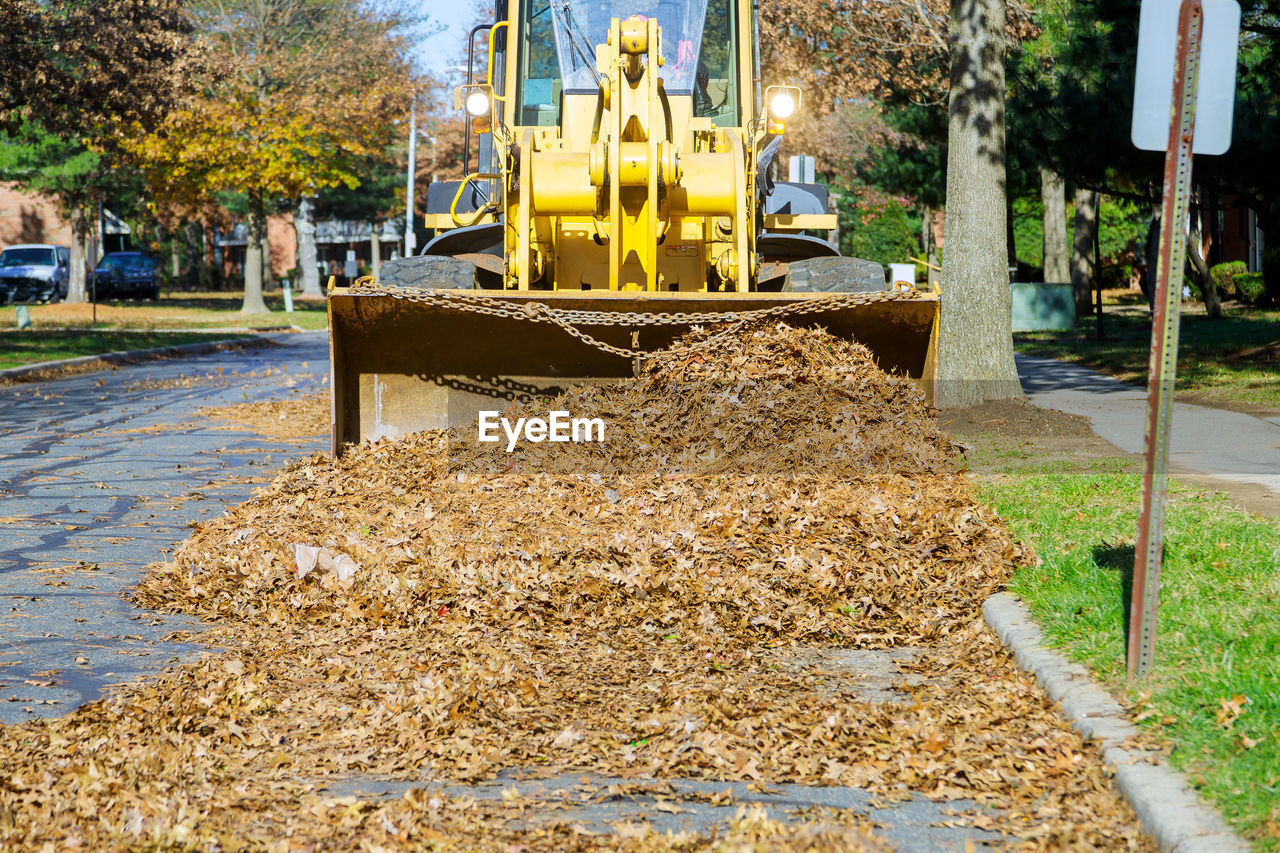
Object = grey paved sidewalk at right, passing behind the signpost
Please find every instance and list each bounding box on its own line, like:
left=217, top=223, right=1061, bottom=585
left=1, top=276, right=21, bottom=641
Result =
left=1016, top=355, right=1280, bottom=496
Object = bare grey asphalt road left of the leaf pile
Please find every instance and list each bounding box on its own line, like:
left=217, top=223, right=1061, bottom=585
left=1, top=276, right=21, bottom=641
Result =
left=0, top=332, right=329, bottom=722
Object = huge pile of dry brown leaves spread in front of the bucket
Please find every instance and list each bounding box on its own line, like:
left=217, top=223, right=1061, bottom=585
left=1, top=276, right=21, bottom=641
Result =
left=0, top=325, right=1148, bottom=850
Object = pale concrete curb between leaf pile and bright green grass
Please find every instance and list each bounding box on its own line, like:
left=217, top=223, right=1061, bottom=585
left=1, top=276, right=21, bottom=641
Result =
left=982, top=593, right=1249, bottom=853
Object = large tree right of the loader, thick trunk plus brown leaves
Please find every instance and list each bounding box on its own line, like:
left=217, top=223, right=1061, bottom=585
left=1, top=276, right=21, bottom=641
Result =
left=760, top=0, right=1036, bottom=406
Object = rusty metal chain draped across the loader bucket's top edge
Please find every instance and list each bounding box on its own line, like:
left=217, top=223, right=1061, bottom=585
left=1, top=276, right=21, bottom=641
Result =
left=351, top=277, right=919, bottom=359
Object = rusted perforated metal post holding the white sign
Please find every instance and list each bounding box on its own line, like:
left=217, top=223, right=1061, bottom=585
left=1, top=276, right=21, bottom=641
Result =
left=1128, top=0, right=1204, bottom=680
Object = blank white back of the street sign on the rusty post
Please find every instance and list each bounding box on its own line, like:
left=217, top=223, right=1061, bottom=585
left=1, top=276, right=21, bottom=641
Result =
left=1132, top=0, right=1240, bottom=154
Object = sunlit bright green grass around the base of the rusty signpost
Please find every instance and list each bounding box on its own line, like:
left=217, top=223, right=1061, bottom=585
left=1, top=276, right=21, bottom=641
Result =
left=979, top=461, right=1280, bottom=850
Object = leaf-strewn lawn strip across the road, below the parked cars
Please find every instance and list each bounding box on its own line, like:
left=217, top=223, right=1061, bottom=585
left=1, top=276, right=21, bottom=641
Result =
left=0, top=292, right=328, bottom=333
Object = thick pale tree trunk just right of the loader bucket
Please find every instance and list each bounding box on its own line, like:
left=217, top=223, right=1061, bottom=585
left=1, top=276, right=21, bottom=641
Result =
left=936, top=0, right=1023, bottom=407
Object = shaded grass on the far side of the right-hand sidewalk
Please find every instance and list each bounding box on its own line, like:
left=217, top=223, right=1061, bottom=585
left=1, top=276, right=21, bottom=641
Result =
left=1014, top=307, right=1280, bottom=409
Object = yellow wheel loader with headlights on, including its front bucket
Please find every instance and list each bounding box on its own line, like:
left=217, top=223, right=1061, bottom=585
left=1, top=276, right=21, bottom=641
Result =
left=329, top=0, right=938, bottom=453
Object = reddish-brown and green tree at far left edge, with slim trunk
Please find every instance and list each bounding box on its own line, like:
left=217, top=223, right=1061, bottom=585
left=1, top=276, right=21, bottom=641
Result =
left=0, top=0, right=205, bottom=301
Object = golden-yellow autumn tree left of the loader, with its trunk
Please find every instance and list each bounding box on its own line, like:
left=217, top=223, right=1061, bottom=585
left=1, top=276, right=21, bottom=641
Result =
left=124, top=0, right=416, bottom=313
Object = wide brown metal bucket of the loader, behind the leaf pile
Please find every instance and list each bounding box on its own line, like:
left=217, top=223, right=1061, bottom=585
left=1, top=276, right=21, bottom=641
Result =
left=329, top=286, right=938, bottom=456
